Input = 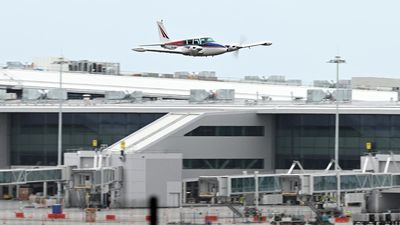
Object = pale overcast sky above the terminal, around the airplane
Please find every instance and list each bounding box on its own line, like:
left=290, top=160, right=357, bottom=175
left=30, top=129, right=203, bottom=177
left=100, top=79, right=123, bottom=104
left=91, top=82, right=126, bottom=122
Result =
left=0, top=0, right=400, bottom=81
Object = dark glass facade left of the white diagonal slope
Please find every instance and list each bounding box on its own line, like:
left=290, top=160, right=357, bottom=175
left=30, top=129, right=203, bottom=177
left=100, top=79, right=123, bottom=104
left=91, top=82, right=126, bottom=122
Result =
left=10, top=113, right=164, bottom=165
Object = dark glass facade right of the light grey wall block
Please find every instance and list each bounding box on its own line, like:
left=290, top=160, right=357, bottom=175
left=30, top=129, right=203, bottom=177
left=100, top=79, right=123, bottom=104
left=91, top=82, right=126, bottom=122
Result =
left=275, top=114, right=400, bottom=169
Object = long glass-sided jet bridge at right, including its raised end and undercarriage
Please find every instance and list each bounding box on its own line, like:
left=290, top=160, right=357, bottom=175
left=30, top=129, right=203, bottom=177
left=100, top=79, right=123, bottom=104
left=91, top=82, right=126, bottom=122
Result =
left=194, top=155, right=400, bottom=207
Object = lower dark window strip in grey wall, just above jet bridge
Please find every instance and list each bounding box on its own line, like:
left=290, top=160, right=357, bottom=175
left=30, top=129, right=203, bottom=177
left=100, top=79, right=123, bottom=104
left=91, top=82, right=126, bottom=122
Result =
left=183, top=159, right=264, bottom=169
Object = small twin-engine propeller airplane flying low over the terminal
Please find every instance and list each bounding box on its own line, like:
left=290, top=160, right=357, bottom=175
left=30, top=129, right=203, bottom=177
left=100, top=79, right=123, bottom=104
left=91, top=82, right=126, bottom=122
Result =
left=132, top=21, right=272, bottom=56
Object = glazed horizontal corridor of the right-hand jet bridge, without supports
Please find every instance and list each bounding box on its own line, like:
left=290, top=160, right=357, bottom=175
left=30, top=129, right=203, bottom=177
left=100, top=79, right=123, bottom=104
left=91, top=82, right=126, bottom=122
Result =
left=199, top=172, right=400, bottom=197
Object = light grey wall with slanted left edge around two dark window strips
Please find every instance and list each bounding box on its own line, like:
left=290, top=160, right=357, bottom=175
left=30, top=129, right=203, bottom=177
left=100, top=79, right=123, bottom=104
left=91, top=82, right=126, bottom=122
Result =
left=143, top=111, right=274, bottom=178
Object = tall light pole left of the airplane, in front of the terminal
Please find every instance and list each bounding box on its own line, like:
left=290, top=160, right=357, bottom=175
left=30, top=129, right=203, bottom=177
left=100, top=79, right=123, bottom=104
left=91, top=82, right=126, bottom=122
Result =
left=53, top=57, right=68, bottom=203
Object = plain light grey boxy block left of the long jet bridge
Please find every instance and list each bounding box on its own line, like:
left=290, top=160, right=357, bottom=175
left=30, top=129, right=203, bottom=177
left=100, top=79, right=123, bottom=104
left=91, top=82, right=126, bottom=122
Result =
left=111, top=153, right=182, bottom=207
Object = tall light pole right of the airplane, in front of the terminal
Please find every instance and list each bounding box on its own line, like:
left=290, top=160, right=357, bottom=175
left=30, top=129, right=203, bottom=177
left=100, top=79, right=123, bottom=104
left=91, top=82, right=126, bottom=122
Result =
left=328, top=56, right=346, bottom=209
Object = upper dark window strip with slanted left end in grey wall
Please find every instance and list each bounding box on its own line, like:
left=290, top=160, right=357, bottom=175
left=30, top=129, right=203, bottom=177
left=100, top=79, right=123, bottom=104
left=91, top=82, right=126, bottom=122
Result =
left=185, top=126, right=264, bottom=137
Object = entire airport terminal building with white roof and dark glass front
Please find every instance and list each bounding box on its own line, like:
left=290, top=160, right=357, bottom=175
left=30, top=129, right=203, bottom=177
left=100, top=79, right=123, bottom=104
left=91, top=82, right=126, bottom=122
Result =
left=0, top=70, right=400, bottom=207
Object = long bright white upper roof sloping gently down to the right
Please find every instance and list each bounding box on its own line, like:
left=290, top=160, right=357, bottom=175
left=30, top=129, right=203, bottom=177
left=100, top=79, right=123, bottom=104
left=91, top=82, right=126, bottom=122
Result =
left=0, top=69, right=397, bottom=101
